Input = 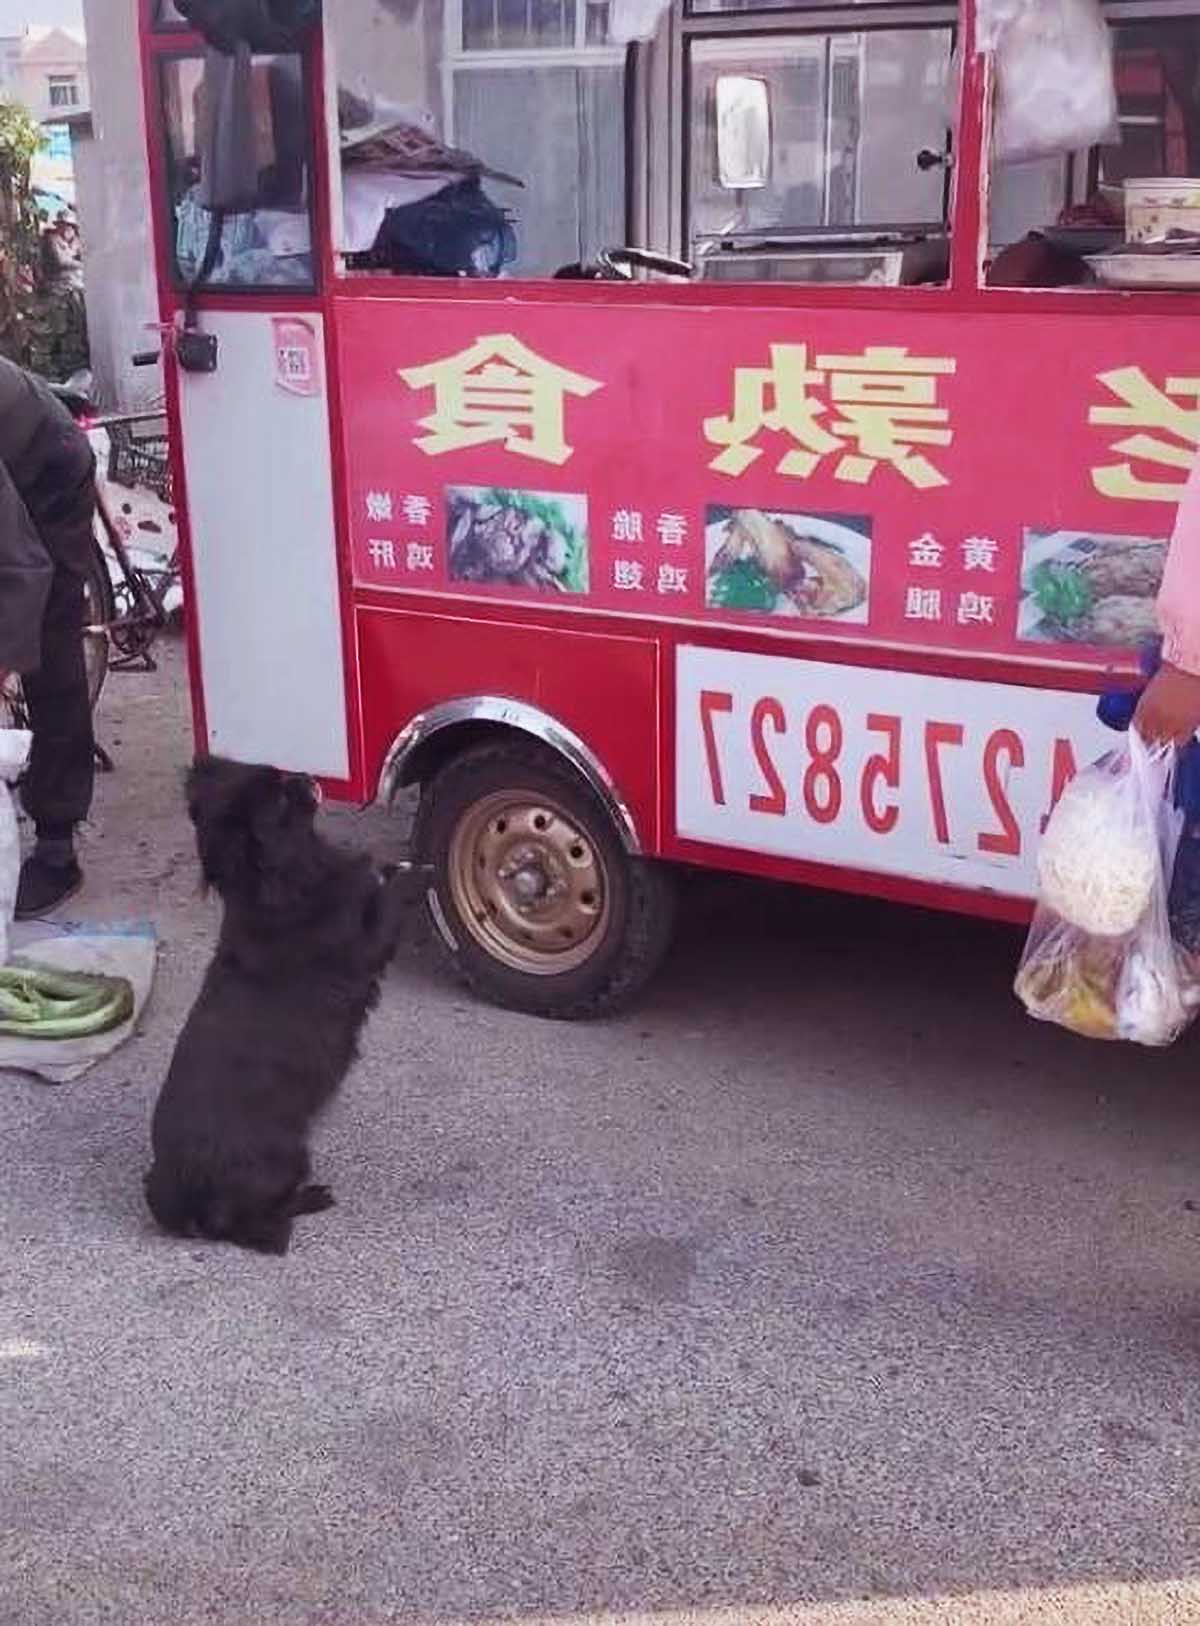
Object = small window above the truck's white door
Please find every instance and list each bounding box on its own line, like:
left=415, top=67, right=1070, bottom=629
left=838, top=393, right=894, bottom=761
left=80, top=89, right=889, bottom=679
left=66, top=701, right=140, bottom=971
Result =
left=161, top=54, right=312, bottom=288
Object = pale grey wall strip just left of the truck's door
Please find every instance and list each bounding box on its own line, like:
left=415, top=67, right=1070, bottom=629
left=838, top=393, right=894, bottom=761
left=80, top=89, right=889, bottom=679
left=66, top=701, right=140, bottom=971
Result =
left=73, top=0, right=163, bottom=408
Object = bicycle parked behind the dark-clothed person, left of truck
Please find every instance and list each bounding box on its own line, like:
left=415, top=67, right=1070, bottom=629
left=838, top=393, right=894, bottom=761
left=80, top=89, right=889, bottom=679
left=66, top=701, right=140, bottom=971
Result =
left=0, top=353, right=180, bottom=751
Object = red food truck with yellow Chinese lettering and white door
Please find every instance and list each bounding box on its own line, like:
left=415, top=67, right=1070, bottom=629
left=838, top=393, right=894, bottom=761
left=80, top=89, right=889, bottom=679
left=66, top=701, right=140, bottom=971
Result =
left=140, top=0, right=1200, bottom=1015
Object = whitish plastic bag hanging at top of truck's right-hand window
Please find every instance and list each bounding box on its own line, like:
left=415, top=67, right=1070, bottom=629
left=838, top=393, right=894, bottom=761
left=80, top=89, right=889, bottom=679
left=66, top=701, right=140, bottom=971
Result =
left=979, top=0, right=1117, bottom=164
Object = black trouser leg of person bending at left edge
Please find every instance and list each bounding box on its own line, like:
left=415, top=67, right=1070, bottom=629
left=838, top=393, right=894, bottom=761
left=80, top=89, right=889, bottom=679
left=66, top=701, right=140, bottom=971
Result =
left=21, top=566, right=96, bottom=841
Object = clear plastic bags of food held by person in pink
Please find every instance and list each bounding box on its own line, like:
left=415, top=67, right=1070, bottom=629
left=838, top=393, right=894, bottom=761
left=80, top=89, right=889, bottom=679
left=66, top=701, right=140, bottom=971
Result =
left=1016, top=730, right=1200, bottom=1046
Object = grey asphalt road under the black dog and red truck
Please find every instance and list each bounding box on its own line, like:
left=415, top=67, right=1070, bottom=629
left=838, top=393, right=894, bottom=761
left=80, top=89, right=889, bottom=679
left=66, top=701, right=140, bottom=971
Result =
left=0, top=652, right=1200, bottom=1626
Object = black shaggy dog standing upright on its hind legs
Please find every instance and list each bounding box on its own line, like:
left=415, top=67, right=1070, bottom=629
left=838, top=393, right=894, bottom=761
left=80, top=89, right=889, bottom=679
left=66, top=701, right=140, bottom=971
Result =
left=146, top=758, right=402, bottom=1254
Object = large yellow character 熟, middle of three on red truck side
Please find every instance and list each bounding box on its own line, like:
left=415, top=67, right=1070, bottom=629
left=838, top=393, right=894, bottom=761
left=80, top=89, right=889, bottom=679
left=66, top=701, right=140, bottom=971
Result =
left=704, top=345, right=958, bottom=491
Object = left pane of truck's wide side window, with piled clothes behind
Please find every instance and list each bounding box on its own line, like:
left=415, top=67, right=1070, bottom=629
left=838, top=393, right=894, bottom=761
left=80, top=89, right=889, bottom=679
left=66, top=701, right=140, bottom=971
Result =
left=325, top=0, right=626, bottom=276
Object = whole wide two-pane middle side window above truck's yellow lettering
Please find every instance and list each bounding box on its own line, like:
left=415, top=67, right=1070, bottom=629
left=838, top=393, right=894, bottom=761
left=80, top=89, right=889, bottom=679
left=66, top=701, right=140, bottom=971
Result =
left=325, top=0, right=954, bottom=283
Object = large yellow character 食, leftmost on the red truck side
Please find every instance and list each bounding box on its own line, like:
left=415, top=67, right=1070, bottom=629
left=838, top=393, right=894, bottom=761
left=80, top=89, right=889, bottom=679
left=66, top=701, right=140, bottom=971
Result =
left=400, top=333, right=600, bottom=463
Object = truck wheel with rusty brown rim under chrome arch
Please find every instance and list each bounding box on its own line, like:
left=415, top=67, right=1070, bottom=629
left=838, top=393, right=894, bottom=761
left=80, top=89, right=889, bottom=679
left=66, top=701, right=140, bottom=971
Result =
left=416, top=743, right=675, bottom=1018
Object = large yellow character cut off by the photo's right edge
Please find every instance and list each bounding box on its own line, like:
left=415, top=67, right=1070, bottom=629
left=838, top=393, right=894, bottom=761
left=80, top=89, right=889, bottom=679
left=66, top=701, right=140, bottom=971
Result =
left=1088, top=367, right=1200, bottom=502
